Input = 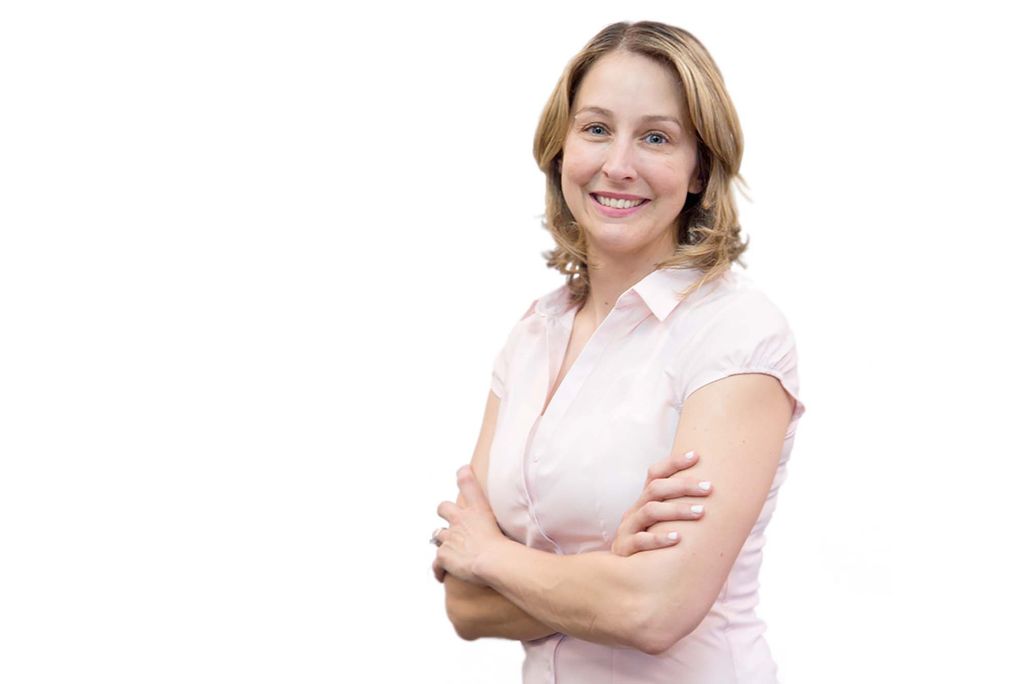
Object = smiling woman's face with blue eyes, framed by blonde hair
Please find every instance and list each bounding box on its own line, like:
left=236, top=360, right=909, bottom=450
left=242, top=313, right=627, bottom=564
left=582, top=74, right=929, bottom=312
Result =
left=561, top=51, right=700, bottom=263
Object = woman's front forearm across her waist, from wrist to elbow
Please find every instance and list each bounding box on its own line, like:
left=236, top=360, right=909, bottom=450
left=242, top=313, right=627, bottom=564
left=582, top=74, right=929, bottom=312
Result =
left=479, top=544, right=654, bottom=651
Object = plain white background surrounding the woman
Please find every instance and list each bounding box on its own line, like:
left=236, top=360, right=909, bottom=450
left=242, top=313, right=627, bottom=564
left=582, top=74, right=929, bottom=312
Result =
left=0, top=1, right=1024, bottom=684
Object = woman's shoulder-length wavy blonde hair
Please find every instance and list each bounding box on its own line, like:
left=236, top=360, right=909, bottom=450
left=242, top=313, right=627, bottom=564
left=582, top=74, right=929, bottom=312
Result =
left=534, top=22, right=746, bottom=304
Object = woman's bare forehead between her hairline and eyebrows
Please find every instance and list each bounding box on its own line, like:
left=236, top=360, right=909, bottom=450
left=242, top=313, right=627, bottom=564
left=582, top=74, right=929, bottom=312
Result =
left=572, top=51, right=685, bottom=119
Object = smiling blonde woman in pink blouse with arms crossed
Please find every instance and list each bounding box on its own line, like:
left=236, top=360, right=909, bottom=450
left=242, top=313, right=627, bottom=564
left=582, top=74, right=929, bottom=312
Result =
left=435, top=22, right=804, bottom=684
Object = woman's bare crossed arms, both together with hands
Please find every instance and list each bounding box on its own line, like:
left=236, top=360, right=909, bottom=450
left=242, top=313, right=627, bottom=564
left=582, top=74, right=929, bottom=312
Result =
left=435, top=374, right=794, bottom=653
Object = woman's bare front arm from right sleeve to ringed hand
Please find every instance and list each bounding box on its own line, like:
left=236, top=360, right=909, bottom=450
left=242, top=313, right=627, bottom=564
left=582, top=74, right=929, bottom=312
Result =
left=448, top=374, right=793, bottom=653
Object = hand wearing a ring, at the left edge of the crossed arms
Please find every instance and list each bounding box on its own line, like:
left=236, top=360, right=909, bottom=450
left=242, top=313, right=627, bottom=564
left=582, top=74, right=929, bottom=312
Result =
left=434, top=466, right=508, bottom=585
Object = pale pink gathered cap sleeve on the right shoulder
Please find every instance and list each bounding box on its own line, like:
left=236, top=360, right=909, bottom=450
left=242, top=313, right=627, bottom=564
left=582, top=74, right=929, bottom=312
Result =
left=682, top=290, right=805, bottom=427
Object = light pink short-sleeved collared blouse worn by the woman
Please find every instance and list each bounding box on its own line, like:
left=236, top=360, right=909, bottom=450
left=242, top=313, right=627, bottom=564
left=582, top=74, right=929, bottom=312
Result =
left=487, top=269, right=804, bottom=684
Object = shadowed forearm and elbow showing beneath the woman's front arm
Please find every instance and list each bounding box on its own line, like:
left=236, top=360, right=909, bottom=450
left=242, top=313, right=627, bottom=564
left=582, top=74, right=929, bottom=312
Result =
left=444, top=574, right=555, bottom=641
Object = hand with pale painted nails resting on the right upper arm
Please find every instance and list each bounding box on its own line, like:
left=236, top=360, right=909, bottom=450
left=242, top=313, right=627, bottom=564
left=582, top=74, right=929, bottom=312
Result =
left=611, top=452, right=711, bottom=556
